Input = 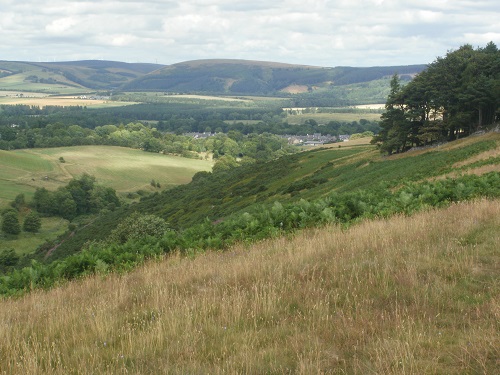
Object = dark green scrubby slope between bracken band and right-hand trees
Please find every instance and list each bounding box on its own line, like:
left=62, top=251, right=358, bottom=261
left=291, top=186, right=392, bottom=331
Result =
left=44, top=133, right=500, bottom=259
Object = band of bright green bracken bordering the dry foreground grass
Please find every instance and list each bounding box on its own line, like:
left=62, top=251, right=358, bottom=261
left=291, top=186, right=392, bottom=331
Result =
left=0, top=156, right=500, bottom=294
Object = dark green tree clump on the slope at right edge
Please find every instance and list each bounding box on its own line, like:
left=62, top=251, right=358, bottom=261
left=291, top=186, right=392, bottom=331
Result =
left=373, top=42, right=500, bottom=155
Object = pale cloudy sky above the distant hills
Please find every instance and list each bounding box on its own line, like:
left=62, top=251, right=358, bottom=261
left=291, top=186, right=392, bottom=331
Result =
left=0, top=0, right=500, bottom=67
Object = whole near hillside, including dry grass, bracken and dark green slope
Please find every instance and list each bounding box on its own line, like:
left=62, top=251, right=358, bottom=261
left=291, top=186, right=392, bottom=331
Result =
left=0, top=132, right=500, bottom=374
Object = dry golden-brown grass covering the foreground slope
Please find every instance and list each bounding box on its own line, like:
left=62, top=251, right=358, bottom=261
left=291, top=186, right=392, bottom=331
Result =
left=0, top=200, right=500, bottom=374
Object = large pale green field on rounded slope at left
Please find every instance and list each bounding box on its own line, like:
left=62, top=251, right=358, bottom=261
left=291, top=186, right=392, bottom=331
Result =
left=0, top=146, right=212, bottom=207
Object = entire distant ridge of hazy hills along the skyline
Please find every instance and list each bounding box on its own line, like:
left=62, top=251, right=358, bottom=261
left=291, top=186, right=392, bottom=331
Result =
left=0, top=59, right=426, bottom=95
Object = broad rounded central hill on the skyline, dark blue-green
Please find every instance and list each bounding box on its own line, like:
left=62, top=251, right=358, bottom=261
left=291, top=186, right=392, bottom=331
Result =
left=122, top=60, right=426, bottom=95
